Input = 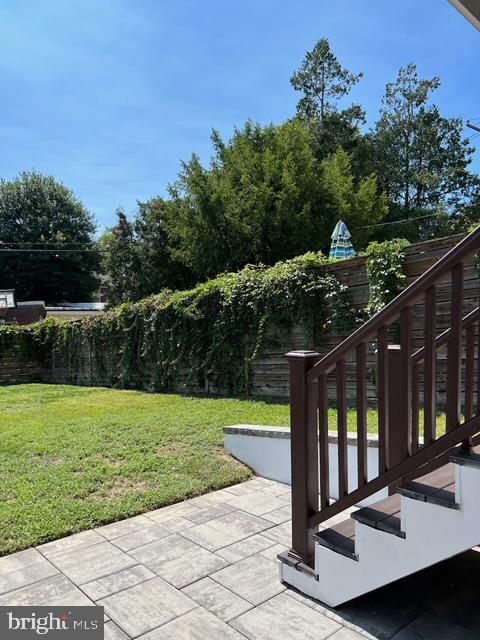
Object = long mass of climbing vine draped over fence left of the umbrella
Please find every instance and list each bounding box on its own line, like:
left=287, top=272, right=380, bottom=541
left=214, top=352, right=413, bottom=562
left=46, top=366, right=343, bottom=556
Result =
left=0, top=253, right=354, bottom=393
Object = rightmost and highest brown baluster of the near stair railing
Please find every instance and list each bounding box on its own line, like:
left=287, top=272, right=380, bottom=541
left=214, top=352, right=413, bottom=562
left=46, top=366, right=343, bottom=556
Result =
left=447, top=262, right=463, bottom=431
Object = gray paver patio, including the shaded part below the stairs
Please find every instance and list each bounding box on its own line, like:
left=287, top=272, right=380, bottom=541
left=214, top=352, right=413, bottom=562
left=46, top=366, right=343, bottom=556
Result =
left=0, top=478, right=480, bottom=640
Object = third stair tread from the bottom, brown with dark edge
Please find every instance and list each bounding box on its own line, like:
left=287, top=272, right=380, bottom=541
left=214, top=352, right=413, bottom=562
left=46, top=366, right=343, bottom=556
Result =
left=396, top=462, right=458, bottom=508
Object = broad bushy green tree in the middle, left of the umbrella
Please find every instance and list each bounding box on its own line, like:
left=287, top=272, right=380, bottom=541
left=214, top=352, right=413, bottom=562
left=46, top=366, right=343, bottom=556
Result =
left=167, top=120, right=331, bottom=280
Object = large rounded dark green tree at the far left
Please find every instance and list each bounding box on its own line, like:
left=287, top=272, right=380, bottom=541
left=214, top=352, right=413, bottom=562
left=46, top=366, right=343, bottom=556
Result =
left=0, top=171, right=100, bottom=303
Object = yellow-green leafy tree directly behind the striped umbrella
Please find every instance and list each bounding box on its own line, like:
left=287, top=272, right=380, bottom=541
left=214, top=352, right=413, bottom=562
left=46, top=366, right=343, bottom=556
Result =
left=321, top=147, right=388, bottom=251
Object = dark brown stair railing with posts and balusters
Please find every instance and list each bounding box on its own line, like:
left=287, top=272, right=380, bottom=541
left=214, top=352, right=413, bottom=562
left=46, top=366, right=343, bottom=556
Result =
left=287, top=229, right=480, bottom=568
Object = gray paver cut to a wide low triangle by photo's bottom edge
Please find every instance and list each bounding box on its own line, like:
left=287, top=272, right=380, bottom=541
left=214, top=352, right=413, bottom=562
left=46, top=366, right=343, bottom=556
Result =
left=142, top=608, right=244, bottom=640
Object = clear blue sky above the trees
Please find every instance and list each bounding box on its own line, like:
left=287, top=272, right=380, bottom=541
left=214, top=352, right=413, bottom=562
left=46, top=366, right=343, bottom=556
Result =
left=0, top=0, right=480, bottom=231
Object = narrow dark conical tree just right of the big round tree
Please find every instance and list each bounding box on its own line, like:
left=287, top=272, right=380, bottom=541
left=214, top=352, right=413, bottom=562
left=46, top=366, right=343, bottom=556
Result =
left=102, top=209, right=140, bottom=306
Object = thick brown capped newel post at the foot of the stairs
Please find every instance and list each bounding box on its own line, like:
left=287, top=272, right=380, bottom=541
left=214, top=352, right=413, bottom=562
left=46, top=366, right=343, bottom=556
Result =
left=286, top=351, right=321, bottom=565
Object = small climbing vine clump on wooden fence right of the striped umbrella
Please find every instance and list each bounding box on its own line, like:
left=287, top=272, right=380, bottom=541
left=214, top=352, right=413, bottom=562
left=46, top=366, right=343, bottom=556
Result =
left=366, top=238, right=409, bottom=316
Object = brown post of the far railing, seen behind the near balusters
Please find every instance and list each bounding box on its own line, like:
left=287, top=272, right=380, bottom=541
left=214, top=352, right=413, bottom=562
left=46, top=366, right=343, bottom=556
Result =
left=385, top=344, right=411, bottom=494
